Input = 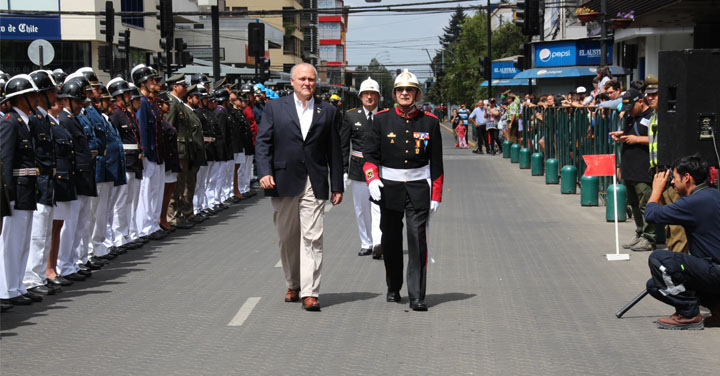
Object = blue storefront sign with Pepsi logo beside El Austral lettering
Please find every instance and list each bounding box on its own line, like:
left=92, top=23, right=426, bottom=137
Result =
left=535, top=41, right=612, bottom=67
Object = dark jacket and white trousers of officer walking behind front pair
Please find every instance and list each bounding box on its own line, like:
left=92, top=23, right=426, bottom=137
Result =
left=340, top=107, right=382, bottom=255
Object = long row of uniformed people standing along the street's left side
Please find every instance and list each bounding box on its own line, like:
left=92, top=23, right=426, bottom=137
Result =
left=0, top=64, right=267, bottom=311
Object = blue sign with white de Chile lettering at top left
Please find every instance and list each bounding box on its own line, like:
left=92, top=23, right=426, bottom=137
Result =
left=0, top=15, right=60, bottom=40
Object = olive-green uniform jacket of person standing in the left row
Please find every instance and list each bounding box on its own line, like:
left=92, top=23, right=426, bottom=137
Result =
left=171, top=95, right=207, bottom=167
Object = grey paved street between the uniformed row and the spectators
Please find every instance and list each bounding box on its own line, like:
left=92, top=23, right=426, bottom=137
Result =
left=0, top=125, right=720, bottom=376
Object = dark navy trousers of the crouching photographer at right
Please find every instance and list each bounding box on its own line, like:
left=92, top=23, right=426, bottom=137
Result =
left=647, top=249, right=720, bottom=317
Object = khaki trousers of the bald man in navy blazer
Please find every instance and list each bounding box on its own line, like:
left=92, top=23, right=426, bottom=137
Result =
left=271, top=178, right=325, bottom=298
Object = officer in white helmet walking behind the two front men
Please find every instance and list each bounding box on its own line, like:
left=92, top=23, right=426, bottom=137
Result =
left=340, top=77, right=382, bottom=260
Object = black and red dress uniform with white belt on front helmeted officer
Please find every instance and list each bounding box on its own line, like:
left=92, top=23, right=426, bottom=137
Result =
left=363, top=108, right=444, bottom=302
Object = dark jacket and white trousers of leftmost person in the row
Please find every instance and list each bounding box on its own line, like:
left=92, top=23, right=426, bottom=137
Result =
left=0, top=107, right=38, bottom=299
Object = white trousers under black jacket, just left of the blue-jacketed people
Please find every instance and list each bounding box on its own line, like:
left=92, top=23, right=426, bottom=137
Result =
left=57, top=196, right=90, bottom=276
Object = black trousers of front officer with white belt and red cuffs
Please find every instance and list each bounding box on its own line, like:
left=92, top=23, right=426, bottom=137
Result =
left=380, top=195, right=430, bottom=301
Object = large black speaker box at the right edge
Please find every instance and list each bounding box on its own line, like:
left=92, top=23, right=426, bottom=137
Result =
left=658, top=49, right=720, bottom=167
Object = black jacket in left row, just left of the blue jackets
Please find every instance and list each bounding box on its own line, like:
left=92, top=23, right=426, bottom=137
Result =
left=59, top=111, right=97, bottom=197
